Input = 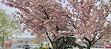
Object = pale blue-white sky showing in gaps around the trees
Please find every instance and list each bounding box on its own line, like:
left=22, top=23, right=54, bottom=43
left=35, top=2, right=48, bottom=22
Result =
left=0, top=0, right=111, bottom=38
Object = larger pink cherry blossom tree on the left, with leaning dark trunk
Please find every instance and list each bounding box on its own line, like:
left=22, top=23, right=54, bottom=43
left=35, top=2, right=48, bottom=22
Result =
left=2, top=0, right=76, bottom=49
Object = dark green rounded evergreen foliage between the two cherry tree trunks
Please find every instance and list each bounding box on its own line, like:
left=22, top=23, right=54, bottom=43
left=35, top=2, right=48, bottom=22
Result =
left=55, top=37, right=76, bottom=48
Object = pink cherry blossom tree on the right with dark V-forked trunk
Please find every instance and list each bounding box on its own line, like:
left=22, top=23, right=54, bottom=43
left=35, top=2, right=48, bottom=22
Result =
left=58, top=0, right=111, bottom=49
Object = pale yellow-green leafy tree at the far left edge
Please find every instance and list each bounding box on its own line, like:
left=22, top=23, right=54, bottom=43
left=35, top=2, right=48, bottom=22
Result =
left=0, top=9, right=16, bottom=48
